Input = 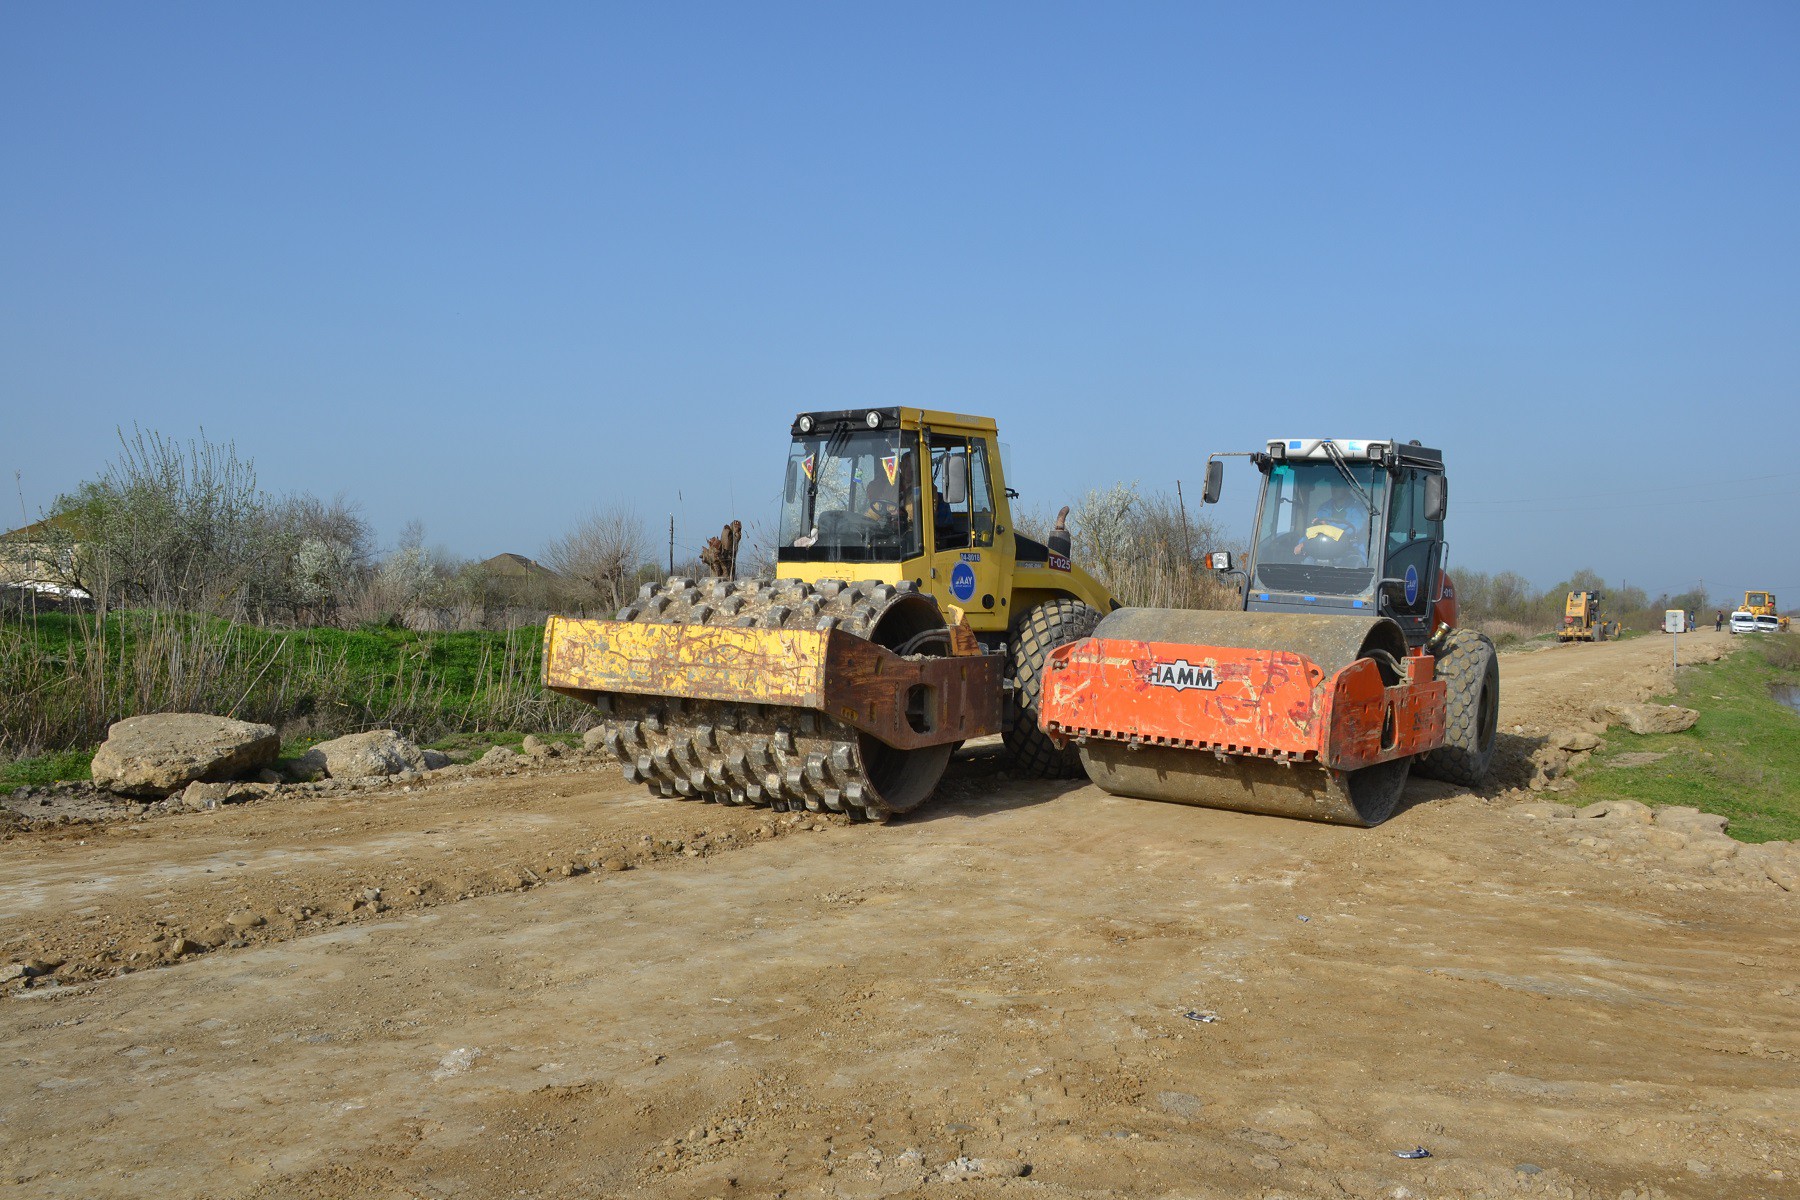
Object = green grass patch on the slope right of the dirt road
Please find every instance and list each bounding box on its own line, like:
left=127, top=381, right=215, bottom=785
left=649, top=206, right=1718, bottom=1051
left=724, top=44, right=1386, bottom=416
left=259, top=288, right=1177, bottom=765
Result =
left=1575, top=633, right=1800, bottom=842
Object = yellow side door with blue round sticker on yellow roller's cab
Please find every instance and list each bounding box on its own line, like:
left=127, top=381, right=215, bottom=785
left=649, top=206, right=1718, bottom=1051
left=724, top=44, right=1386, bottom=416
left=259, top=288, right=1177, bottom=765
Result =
left=927, top=432, right=1012, bottom=630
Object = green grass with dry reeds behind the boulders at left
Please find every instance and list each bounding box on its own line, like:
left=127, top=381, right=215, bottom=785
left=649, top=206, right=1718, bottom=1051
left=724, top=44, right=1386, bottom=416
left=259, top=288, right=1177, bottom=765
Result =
left=0, top=610, right=590, bottom=790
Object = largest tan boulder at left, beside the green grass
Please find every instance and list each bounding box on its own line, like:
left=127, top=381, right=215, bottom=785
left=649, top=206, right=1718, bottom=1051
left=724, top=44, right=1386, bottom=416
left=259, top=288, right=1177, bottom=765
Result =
left=94, top=712, right=281, bottom=795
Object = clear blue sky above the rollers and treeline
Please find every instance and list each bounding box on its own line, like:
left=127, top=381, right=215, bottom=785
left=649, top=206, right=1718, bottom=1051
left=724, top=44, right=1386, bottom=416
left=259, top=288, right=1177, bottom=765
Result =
left=0, top=4, right=1800, bottom=597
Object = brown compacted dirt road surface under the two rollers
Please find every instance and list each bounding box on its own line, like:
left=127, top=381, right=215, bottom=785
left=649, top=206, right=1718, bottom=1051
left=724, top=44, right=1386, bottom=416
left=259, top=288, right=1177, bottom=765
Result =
left=0, top=635, right=1800, bottom=1200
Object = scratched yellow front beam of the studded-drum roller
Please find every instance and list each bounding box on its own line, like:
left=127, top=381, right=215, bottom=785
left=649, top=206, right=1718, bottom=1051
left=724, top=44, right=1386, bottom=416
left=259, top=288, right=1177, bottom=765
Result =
left=544, top=617, right=830, bottom=709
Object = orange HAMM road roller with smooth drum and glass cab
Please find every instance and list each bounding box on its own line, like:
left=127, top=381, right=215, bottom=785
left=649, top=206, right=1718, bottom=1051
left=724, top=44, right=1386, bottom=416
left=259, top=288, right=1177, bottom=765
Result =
left=1039, top=439, right=1499, bottom=826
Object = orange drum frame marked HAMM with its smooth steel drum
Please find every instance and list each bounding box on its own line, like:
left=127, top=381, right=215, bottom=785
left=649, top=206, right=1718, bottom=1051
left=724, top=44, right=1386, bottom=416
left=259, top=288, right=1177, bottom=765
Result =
left=1040, top=610, right=1445, bottom=824
